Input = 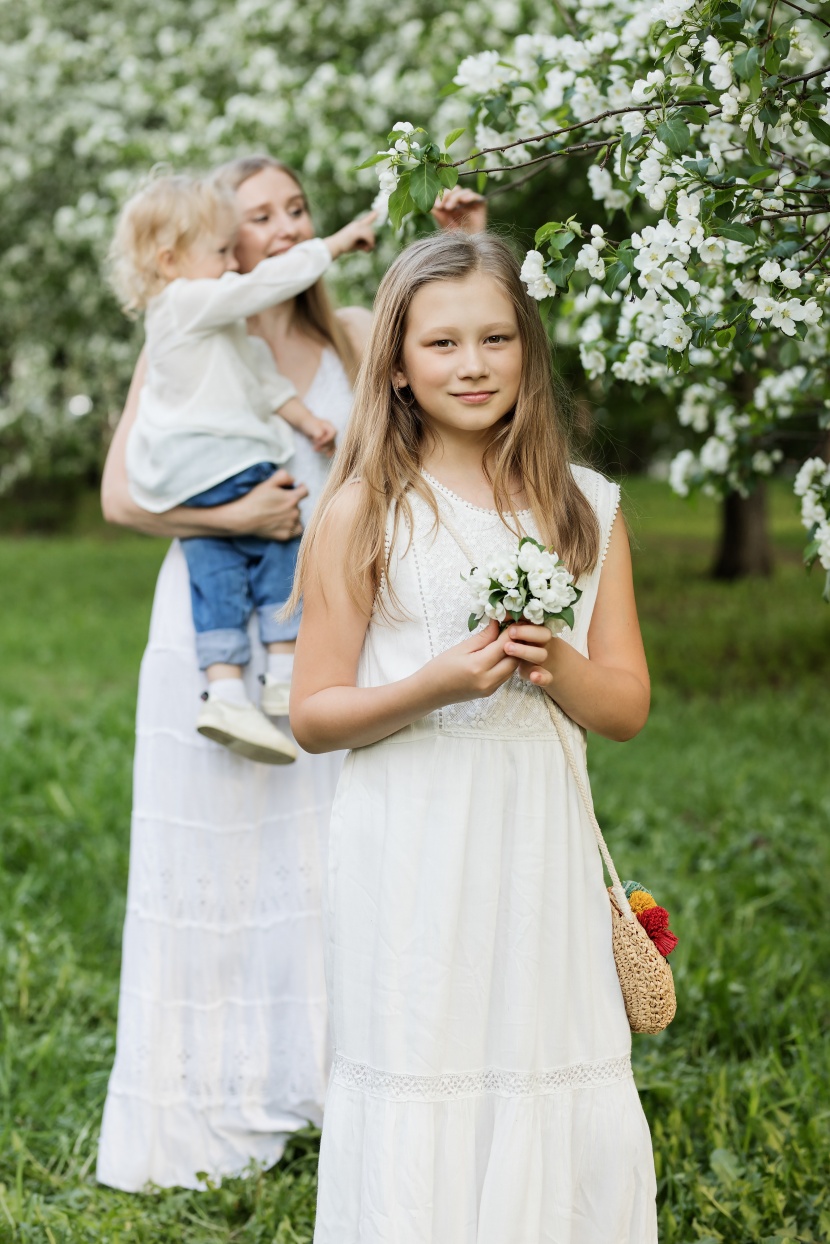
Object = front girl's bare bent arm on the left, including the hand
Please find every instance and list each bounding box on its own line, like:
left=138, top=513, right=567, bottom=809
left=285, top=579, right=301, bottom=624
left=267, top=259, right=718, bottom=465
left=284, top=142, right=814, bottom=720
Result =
left=291, top=485, right=518, bottom=751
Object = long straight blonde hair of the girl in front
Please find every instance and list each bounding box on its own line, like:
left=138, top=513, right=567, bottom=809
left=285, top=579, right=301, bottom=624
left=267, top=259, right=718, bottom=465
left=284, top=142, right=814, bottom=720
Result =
left=286, top=231, right=600, bottom=616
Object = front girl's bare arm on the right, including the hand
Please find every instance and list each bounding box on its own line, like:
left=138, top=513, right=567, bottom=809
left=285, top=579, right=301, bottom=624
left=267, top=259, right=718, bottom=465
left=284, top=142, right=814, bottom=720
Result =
left=504, top=515, right=651, bottom=743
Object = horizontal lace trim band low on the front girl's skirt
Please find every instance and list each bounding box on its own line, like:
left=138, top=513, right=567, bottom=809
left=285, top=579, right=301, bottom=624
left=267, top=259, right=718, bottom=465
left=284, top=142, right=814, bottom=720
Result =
left=332, top=1054, right=632, bottom=1101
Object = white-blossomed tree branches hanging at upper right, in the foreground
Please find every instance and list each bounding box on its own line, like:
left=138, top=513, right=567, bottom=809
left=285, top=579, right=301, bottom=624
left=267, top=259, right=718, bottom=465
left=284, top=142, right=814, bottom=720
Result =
left=366, top=0, right=830, bottom=600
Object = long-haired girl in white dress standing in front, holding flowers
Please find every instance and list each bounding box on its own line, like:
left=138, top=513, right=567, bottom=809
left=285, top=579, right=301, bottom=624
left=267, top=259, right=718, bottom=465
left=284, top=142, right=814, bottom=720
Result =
left=291, top=234, right=657, bottom=1244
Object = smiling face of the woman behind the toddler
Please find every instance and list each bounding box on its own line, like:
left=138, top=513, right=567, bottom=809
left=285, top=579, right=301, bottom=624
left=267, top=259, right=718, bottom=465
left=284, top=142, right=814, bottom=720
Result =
left=236, top=168, right=314, bottom=272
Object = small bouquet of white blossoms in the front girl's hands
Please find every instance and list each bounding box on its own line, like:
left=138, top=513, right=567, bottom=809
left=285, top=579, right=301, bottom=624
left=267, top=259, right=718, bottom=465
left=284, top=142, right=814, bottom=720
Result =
left=462, top=536, right=582, bottom=634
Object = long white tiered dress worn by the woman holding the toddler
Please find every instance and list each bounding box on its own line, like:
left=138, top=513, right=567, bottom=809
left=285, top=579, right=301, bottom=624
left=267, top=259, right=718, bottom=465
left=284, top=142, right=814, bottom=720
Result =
left=97, top=350, right=352, bottom=1192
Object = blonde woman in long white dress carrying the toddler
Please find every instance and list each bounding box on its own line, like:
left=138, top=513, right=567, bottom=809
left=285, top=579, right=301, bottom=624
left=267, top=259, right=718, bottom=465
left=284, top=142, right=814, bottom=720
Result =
left=97, top=157, right=483, bottom=1192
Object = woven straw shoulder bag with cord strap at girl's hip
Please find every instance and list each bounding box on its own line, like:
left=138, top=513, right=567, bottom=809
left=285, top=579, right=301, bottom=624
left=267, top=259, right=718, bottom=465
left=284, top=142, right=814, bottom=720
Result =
left=549, top=699, right=677, bottom=1034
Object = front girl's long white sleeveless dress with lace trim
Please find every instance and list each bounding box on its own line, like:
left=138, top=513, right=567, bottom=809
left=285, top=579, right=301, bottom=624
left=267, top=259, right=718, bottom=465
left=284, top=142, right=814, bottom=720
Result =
left=315, top=468, right=657, bottom=1244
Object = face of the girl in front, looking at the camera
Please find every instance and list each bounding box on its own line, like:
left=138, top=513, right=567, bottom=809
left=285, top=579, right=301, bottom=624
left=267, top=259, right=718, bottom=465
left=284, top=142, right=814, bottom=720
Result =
left=393, top=272, right=523, bottom=437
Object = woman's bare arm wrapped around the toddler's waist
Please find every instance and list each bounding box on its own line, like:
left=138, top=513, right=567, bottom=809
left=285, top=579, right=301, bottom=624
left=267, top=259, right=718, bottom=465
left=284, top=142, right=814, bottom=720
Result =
left=101, top=351, right=309, bottom=540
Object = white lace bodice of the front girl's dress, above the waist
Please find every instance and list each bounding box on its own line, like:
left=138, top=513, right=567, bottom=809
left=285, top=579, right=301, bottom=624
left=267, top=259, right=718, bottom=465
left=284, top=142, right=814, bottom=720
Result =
left=358, top=467, right=620, bottom=741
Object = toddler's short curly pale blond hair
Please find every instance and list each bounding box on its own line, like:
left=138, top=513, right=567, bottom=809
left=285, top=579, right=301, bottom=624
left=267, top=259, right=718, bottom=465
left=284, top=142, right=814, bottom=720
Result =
left=108, top=174, right=239, bottom=315
